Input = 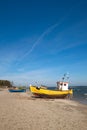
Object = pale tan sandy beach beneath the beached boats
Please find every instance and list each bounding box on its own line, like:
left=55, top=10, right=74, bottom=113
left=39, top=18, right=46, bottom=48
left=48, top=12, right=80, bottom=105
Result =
left=0, top=89, right=87, bottom=130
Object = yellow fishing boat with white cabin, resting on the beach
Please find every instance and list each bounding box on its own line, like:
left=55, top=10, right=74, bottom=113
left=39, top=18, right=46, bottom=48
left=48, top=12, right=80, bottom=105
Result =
left=30, top=81, right=73, bottom=98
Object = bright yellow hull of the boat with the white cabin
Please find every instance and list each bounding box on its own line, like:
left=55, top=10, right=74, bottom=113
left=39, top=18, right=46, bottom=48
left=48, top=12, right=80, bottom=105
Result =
left=30, top=86, right=73, bottom=98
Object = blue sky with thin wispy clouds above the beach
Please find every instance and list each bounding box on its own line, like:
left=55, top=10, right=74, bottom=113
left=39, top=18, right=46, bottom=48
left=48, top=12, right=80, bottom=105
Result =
left=0, top=0, right=87, bottom=86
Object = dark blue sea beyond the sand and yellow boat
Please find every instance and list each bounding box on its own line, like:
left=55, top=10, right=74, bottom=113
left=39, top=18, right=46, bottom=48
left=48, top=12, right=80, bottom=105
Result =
left=48, top=86, right=87, bottom=105
